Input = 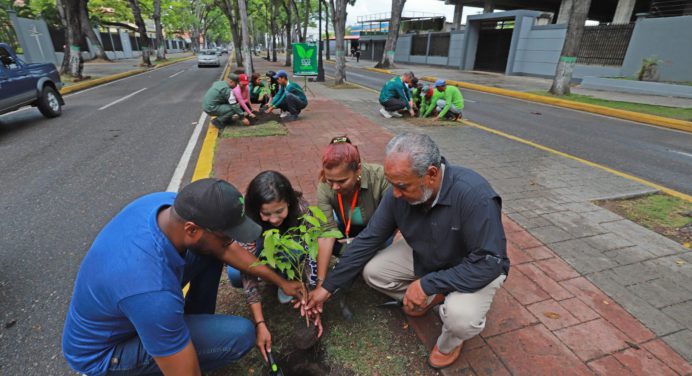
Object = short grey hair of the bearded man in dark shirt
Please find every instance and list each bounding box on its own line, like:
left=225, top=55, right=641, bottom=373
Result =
left=384, top=133, right=442, bottom=176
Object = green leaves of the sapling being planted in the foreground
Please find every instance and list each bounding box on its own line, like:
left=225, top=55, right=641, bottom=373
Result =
left=259, top=206, right=343, bottom=282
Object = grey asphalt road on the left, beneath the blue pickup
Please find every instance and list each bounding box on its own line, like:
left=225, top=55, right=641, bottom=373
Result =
left=0, top=60, right=223, bottom=376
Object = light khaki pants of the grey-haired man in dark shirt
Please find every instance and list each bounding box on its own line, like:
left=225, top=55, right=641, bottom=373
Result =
left=363, top=240, right=506, bottom=354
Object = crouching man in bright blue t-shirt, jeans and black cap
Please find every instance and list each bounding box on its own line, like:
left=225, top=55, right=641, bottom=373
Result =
left=62, top=179, right=300, bottom=376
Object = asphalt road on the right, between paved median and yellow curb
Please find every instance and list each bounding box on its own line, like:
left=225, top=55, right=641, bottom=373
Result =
left=324, top=64, right=692, bottom=194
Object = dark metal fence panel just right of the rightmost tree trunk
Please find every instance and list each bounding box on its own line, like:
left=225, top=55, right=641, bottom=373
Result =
left=577, top=23, right=634, bottom=66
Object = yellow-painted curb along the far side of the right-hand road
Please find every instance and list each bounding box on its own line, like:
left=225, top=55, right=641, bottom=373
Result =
left=420, top=76, right=692, bottom=132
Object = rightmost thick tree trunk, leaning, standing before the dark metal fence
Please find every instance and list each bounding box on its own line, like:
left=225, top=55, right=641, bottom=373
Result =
left=550, top=0, right=591, bottom=95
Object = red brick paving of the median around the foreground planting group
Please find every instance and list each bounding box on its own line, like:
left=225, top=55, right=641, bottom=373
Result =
left=214, top=62, right=692, bottom=375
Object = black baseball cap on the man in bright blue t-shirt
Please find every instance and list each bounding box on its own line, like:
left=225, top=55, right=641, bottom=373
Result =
left=173, top=178, right=262, bottom=243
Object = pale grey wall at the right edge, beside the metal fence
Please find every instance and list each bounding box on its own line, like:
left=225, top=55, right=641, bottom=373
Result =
left=622, top=16, right=692, bottom=81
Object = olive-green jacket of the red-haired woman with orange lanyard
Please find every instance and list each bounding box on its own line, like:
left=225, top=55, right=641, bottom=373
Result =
left=317, top=163, right=389, bottom=239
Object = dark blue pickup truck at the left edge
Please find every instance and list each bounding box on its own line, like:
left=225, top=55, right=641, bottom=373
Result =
left=0, top=43, right=65, bottom=118
